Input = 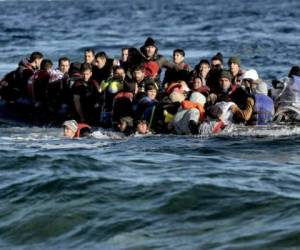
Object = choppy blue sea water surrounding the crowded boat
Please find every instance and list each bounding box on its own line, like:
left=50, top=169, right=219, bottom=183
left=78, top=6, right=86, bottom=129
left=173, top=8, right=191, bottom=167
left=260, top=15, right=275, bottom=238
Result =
left=0, top=0, right=300, bottom=249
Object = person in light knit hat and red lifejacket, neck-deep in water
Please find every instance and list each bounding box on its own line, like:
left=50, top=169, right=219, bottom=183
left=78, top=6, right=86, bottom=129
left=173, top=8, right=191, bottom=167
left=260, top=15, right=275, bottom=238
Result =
left=63, top=120, right=92, bottom=138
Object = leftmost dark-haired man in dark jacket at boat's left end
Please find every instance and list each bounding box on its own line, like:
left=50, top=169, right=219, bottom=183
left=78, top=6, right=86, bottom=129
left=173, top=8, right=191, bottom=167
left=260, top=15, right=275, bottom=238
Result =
left=0, top=51, right=44, bottom=104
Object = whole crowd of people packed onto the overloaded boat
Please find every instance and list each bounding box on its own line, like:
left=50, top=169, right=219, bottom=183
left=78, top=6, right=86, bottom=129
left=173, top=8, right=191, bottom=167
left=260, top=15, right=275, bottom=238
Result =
left=0, top=37, right=300, bottom=137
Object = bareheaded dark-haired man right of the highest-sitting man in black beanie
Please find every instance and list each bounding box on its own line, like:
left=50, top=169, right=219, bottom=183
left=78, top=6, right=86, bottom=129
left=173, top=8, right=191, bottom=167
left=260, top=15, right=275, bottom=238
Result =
left=163, top=49, right=192, bottom=88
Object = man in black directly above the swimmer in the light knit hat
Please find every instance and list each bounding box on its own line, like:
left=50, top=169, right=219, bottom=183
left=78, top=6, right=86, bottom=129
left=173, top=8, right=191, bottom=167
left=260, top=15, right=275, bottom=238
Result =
left=72, top=63, right=100, bottom=124
